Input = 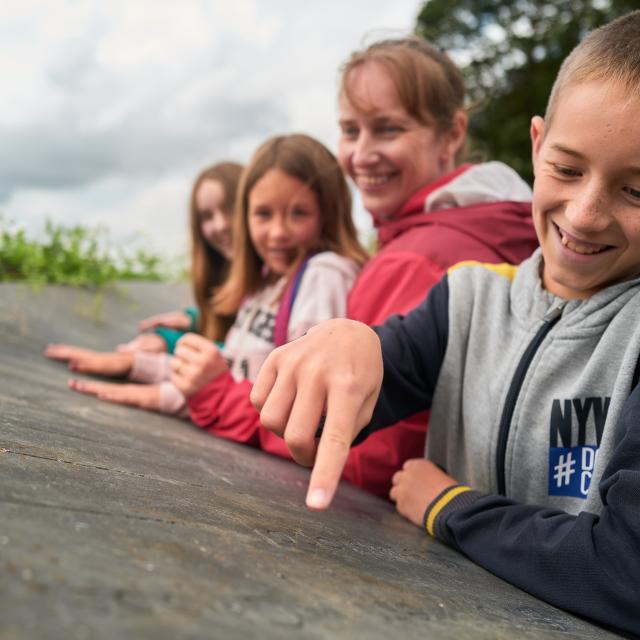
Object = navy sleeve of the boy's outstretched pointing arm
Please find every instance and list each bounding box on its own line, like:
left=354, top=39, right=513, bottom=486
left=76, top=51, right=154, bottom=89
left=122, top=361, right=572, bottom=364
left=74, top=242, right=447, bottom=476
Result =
left=354, top=275, right=449, bottom=444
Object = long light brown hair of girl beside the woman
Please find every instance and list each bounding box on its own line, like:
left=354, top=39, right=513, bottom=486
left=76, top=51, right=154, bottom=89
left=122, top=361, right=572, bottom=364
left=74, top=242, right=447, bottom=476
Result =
left=213, top=134, right=367, bottom=318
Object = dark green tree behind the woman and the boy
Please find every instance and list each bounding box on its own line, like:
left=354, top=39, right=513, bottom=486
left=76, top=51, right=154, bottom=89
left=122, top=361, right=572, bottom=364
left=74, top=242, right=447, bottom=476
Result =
left=416, top=0, right=638, bottom=181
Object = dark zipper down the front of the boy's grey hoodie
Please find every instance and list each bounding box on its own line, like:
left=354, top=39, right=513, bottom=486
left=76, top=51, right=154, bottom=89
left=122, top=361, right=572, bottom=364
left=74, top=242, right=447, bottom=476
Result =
left=496, top=302, right=566, bottom=495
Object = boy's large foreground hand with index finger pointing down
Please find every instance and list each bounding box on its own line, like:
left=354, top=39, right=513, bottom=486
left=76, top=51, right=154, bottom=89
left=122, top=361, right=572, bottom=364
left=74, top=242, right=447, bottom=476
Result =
left=251, top=319, right=382, bottom=510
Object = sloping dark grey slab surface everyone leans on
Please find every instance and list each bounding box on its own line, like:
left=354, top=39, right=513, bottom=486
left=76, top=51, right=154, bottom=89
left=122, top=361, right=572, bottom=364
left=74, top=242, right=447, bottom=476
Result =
left=0, top=283, right=616, bottom=640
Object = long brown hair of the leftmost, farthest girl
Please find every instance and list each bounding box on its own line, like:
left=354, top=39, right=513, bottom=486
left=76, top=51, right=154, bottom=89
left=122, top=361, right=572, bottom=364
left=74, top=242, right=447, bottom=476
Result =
left=189, top=162, right=242, bottom=340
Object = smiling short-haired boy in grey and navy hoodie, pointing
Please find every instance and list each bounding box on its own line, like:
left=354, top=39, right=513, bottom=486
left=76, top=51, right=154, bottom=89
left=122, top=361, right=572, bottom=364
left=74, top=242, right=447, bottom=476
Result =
left=252, top=11, right=640, bottom=634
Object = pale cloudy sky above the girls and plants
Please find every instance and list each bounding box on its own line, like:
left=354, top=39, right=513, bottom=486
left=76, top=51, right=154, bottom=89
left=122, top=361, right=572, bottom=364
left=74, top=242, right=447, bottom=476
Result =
left=0, top=0, right=421, bottom=256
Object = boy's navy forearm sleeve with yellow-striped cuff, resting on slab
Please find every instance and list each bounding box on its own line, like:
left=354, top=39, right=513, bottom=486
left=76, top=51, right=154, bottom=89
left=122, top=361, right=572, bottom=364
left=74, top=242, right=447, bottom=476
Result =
left=425, top=485, right=640, bottom=634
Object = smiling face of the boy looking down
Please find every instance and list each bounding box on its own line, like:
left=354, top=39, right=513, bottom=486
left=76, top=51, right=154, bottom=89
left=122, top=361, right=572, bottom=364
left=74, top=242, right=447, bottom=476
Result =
left=531, top=81, right=640, bottom=299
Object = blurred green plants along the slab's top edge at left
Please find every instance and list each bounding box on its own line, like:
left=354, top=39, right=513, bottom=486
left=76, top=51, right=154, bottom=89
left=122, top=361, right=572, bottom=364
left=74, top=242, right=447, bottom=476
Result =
left=0, top=218, right=175, bottom=288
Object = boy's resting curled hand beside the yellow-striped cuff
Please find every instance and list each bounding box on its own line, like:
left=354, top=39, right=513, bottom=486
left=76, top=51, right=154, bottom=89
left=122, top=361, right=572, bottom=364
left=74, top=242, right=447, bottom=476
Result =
left=389, top=458, right=457, bottom=527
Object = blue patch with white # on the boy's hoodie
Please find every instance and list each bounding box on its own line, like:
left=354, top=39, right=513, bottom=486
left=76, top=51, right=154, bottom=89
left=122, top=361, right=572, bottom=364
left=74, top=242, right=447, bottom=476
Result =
left=549, top=446, right=598, bottom=500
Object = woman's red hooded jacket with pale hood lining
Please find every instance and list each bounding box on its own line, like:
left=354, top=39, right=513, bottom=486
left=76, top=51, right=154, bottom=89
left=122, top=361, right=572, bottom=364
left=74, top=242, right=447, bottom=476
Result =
left=189, top=163, right=538, bottom=497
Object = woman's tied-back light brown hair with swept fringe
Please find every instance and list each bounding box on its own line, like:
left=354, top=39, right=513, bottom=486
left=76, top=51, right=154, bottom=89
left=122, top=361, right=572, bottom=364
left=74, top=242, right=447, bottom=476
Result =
left=339, top=36, right=465, bottom=160
